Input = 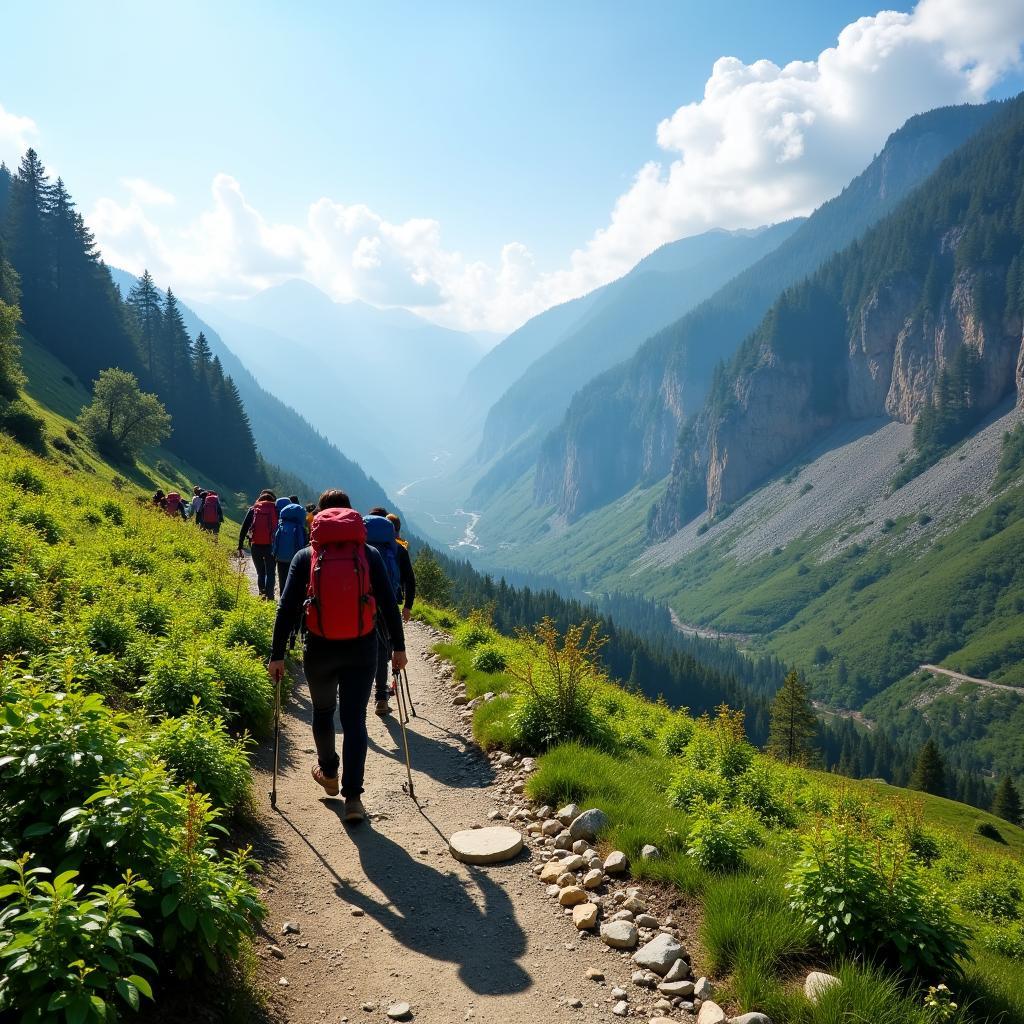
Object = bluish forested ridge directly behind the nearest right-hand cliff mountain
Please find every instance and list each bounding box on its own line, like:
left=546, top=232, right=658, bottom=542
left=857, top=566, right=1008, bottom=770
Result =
left=535, top=103, right=998, bottom=518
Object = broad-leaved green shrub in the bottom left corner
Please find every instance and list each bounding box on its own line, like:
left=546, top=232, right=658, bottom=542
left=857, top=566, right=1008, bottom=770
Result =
left=0, top=855, right=157, bottom=1024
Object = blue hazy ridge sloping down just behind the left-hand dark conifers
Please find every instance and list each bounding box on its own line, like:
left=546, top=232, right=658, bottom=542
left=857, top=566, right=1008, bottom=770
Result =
left=111, top=267, right=393, bottom=508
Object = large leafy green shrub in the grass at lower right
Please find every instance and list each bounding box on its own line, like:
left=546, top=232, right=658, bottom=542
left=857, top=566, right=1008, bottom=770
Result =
left=787, top=820, right=970, bottom=974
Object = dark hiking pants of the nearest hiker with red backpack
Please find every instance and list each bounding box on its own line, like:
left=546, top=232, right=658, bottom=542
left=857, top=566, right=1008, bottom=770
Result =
left=302, top=641, right=376, bottom=798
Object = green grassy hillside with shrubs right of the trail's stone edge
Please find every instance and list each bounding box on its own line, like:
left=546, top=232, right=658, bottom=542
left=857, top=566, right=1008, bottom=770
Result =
left=420, top=607, right=1024, bottom=1024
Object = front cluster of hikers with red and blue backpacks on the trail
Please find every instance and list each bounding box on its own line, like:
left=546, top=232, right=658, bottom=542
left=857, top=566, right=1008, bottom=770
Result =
left=238, top=489, right=416, bottom=822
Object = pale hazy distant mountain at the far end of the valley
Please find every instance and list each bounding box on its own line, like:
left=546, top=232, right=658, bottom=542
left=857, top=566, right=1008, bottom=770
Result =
left=195, top=280, right=480, bottom=486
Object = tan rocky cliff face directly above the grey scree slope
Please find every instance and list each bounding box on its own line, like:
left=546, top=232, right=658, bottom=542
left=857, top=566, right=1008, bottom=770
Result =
left=651, top=268, right=1024, bottom=537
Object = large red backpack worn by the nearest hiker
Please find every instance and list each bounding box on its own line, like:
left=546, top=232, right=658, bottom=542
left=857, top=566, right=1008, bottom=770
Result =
left=305, top=509, right=377, bottom=640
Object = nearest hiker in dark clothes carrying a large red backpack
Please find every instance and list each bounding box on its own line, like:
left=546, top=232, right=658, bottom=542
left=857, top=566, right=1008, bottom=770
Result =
left=267, top=490, right=408, bottom=822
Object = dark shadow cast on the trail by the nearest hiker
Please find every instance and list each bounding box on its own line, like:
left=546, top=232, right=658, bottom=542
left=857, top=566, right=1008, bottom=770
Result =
left=326, top=815, right=532, bottom=995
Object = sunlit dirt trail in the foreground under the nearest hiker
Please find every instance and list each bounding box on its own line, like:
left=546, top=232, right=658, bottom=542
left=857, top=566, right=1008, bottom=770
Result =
left=245, top=565, right=630, bottom=1024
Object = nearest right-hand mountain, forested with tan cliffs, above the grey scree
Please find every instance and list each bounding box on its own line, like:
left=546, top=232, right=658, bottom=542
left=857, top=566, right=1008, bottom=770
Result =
left=651, top=97, right=1024, bottom=536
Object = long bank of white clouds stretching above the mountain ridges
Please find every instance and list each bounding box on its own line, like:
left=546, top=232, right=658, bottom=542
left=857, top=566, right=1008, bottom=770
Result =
left=86, top=0, right=1024, bottom=331
